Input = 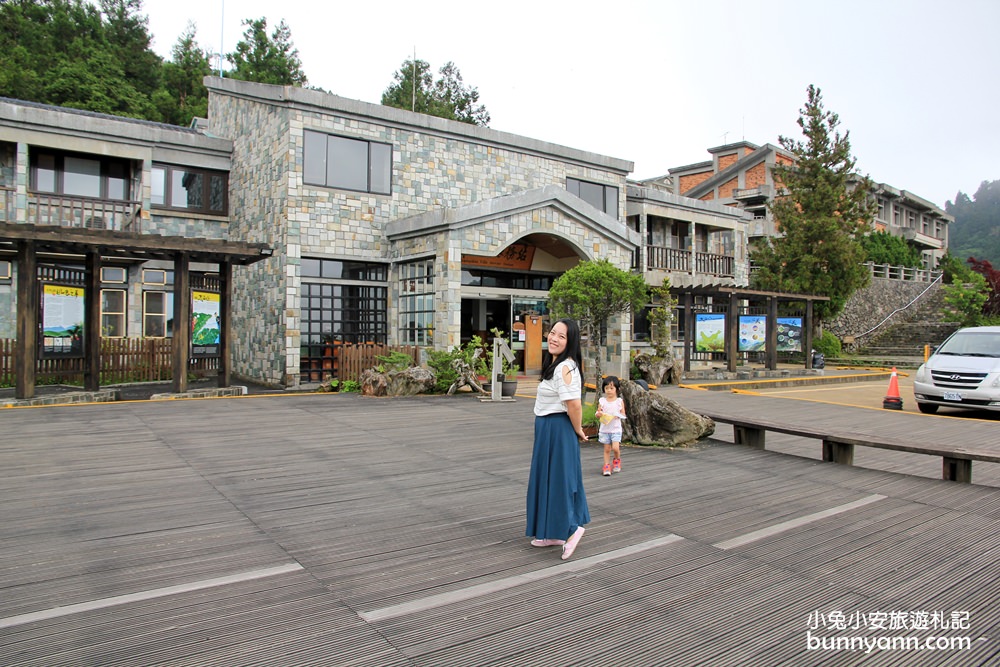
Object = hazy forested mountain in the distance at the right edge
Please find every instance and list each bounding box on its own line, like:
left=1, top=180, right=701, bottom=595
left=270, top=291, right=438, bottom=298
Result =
left=944, top=181, right=1000, bottom=268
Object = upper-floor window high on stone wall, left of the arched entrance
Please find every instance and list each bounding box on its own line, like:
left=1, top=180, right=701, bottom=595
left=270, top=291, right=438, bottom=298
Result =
left=303, top=130, right=392, bottom=195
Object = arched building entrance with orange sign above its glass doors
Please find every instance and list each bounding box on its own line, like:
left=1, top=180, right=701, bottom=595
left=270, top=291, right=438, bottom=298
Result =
left=461, top=233, right=581, bottom=375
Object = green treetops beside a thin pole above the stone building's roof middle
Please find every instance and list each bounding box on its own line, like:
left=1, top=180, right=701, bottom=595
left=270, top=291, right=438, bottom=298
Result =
left=382, top=59, right=490, bottom=127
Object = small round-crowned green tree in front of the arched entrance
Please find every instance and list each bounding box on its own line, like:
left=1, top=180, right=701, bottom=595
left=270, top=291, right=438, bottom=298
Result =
left=549, top=259, right=649, bottom=403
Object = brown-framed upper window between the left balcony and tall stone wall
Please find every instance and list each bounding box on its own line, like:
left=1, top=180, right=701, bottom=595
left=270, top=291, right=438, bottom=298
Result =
left=151, top=164, right=229, bottom=215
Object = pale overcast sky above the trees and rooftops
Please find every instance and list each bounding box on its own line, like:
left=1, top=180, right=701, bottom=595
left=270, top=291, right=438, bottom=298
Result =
left=143, top=0, right=1000, bottom=207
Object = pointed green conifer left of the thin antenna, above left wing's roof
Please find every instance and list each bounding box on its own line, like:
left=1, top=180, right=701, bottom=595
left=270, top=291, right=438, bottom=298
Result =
left=153, top=22, right=212, bottom=126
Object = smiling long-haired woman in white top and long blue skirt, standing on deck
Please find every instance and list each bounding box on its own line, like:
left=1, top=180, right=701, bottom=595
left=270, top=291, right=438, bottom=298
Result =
left=525, top=319, right=590, bottom=560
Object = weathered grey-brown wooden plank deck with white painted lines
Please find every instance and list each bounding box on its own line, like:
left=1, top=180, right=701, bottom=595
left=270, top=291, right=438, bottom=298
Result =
left=0, top=390, right=1000, bottom=667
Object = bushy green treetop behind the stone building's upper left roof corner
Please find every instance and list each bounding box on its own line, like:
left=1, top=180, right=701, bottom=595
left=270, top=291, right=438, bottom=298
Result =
left=226, top=17, right=307, bottom=86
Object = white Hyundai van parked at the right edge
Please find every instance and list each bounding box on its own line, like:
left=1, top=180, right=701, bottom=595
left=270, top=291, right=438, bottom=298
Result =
left=913, top=327, right=1000, bottom=413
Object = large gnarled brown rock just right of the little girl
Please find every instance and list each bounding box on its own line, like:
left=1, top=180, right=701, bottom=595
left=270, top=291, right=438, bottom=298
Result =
left=622, top=381, right=715, bottom=447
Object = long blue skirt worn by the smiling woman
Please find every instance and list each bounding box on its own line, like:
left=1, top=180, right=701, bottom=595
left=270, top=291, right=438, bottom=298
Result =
left=525, top=412, right=590, bottom=540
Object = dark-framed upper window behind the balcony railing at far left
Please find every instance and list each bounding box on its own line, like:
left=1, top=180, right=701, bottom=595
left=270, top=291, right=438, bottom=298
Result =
left=30, top=150, right=130, bottom=201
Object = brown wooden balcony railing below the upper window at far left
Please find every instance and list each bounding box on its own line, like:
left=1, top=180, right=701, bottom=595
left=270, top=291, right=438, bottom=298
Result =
left=26, top=193, right=142, bottom=232
